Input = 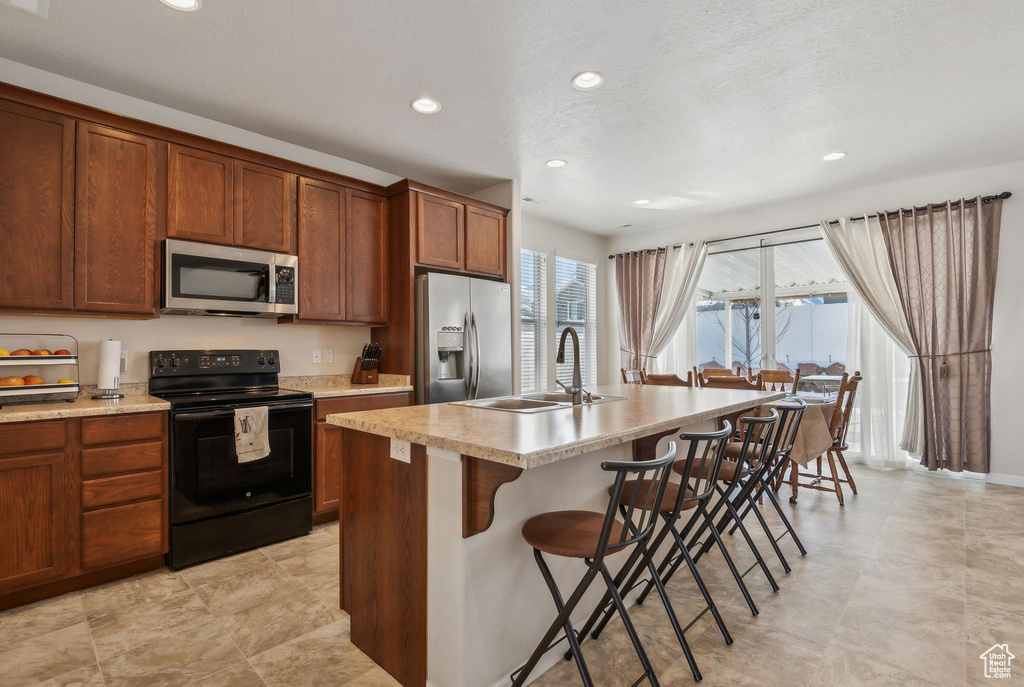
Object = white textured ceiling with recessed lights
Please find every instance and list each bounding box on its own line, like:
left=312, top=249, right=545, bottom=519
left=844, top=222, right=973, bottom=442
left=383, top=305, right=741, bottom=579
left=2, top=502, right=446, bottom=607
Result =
left=0, top=0, right=1024, bottom=233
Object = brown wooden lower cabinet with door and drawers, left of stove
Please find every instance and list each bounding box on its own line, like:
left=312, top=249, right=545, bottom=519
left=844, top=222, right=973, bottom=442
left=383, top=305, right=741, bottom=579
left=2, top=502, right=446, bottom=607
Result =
left=0, top=413, right=168, bottom=610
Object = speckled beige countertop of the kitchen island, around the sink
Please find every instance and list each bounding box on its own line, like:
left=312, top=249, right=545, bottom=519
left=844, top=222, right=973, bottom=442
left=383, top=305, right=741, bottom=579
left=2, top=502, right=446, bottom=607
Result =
left=327, top=384, right=786, bottom=468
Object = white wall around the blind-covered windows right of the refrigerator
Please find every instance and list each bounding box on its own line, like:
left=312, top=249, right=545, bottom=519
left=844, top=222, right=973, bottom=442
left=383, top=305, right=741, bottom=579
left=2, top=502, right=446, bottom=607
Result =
left=513, top=212, right=606, bottom=389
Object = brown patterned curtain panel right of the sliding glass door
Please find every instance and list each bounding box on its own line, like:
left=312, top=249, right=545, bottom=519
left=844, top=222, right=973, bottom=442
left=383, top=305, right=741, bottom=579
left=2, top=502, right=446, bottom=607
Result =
left=879, top=198, right=1002, bottom=472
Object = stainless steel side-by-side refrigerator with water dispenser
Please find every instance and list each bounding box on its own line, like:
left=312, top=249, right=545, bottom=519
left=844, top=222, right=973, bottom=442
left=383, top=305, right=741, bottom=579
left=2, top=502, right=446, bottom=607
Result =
left=416, top=273, right=512, bottom=403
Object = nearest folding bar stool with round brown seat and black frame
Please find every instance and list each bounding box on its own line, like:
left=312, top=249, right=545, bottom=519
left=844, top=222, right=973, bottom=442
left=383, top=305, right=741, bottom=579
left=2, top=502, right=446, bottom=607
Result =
left=511, top=444, right=676, bottom=687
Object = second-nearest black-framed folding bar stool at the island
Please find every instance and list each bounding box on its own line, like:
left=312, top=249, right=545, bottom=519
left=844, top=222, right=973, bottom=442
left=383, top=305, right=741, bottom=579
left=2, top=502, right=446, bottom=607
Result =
left=566, top=422, right=732, bottom=682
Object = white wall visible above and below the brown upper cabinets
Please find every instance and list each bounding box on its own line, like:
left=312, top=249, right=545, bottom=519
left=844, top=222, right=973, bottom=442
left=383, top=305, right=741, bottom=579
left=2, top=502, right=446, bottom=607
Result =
left=0, top=59, right=400, bottom=384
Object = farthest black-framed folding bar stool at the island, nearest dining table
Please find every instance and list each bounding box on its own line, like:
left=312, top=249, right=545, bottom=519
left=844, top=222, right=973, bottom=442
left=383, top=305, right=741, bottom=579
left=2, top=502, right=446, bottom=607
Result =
left=725, top=399, right=807, bottom=572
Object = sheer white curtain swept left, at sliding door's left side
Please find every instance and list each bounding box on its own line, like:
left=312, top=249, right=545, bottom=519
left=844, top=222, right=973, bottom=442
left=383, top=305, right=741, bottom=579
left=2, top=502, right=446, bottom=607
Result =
left=647, top=241, right=708, bottom=370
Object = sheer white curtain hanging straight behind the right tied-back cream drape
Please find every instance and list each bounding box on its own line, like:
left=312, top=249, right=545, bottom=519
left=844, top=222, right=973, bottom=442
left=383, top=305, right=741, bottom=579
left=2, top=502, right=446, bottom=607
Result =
left=846, top=290, right=918, bottom=468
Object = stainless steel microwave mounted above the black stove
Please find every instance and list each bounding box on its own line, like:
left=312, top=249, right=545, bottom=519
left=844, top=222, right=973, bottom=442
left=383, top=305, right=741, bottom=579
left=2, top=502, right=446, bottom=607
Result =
left=161, top=239, right=299, bottom=317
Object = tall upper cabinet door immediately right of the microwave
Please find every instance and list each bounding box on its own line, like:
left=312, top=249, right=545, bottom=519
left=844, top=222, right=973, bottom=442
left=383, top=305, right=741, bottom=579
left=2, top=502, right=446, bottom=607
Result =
left=298, top=177, right=345, bottom=321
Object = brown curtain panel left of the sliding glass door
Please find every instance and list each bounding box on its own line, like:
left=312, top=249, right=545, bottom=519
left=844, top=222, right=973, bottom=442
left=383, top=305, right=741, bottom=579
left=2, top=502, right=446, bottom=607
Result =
left=615, top=250, right=668, bottom=370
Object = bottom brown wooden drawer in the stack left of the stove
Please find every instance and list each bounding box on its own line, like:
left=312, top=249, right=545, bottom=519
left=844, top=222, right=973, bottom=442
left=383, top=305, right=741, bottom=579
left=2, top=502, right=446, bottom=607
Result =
left=82, top=499, right=167, bottom=570
